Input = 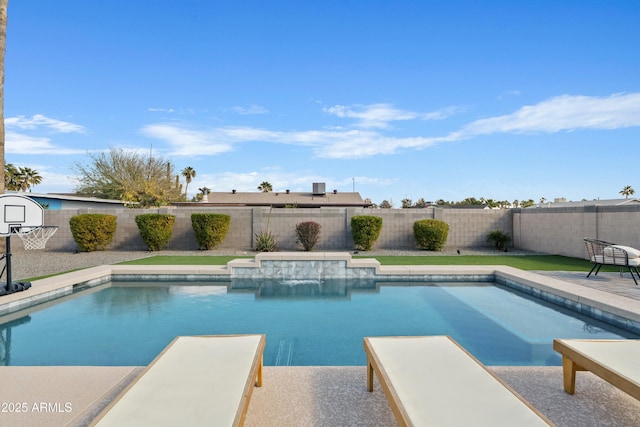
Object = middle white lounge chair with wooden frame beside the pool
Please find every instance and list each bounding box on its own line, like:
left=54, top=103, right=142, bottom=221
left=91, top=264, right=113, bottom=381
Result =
left=364, top=336, right=553, bottom=427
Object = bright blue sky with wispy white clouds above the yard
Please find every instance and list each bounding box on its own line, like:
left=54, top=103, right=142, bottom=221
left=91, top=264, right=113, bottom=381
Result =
left=5, top=0, right=640, bottom=207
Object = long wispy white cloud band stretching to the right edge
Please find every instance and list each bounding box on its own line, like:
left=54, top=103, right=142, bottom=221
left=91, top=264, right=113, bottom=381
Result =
left=142, top=93, right=640, bottom=160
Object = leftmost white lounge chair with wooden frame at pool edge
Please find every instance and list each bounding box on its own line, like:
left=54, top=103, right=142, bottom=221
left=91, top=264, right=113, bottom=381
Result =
left=92, top=335, right=265, bottom=427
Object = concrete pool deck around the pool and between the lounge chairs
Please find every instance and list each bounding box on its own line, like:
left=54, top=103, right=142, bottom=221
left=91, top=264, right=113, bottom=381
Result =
left=0, top=253, right=640, bottom=427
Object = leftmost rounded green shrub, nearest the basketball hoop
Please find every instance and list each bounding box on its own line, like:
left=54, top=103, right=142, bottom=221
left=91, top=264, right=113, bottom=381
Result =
left=69, top=214, right=118, bottom=252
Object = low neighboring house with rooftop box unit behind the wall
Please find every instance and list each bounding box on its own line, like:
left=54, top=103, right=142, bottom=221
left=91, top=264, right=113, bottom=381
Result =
left=174, top=183, right=371, bottom=208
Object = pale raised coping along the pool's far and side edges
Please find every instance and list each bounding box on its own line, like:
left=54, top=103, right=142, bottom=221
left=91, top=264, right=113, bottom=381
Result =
left=0, top=252, right=640, bottom=333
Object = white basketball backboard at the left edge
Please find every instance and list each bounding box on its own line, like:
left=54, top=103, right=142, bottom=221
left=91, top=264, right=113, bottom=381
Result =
left=0, top=194, right=44, bottom=237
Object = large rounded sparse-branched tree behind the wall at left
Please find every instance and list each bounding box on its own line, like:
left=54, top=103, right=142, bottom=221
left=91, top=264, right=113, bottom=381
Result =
left=75, top=148, right=182, bottom=207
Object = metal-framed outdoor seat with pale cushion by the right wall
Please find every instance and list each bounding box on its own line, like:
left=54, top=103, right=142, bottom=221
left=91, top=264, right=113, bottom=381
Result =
left=584, top=238, right=640, bottom=285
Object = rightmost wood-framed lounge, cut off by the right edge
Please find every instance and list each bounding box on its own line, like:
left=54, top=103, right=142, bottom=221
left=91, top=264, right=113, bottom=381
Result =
left=553, top=339, right=640, bottom=399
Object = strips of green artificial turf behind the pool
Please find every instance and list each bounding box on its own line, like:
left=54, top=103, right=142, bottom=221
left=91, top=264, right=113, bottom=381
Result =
left=121, top=255, right=604, bottom=271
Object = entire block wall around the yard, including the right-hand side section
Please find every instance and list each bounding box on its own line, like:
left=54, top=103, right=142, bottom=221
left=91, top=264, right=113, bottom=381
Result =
left=22, top=205, right=640, bottom=258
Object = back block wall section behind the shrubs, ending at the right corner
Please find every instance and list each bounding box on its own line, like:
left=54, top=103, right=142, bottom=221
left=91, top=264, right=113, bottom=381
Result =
left=28, top=207, right=512, bottom=251
